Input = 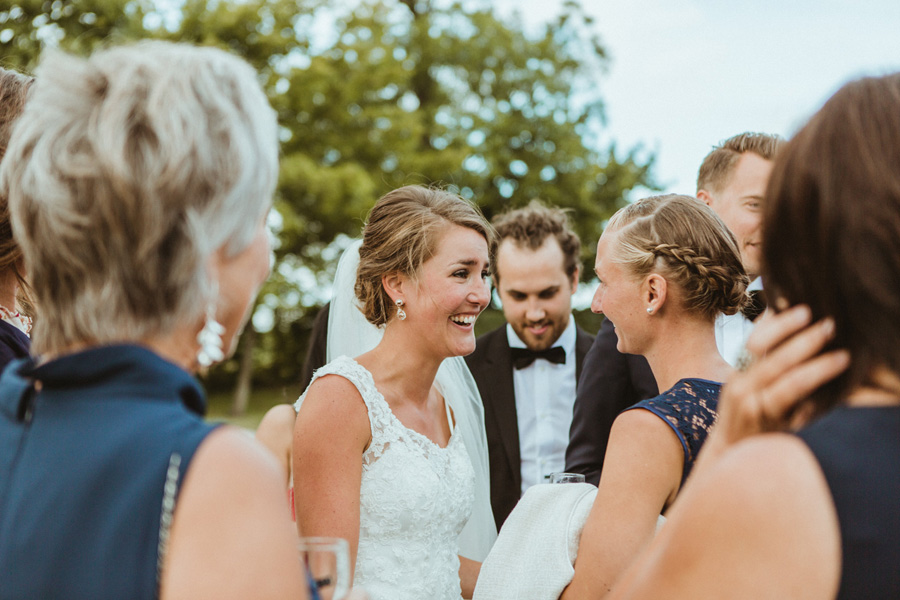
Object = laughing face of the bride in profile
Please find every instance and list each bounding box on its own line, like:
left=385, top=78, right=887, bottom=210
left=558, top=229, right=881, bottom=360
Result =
left=403, top=225, right=490, bottom=356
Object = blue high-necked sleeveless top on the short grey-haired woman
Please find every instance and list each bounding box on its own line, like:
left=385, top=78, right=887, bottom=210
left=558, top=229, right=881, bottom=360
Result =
left=0, top=345, right=214, bottom=600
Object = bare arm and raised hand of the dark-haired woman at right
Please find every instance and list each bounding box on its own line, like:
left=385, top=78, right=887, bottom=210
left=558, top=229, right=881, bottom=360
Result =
left=613, top=306, right=849, bottom=599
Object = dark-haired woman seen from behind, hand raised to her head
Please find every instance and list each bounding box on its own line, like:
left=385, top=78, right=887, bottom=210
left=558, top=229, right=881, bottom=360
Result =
left=604, top=74, right=900, bottom=600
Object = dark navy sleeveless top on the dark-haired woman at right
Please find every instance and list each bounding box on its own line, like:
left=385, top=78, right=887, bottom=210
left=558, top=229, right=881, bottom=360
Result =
left=797, top=406, right=900, bottom=600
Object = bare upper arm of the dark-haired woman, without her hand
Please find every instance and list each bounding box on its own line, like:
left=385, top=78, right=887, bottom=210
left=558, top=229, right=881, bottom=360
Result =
left=612, top=434, right=841, bottom=600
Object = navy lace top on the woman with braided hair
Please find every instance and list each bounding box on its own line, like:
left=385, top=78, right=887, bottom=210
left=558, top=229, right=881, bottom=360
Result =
left=627, top=378, right=722, bottom=485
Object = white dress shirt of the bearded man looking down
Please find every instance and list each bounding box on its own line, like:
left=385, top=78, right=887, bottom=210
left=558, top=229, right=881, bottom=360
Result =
left=506, top=317, right=576, bottom=494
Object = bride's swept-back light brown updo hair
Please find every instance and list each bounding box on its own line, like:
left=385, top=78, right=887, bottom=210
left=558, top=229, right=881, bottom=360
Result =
left=354, top=185, right=495, bottom=327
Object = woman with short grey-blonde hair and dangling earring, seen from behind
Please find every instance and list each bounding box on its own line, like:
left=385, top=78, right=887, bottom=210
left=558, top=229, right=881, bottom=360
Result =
left=0, top=42, right=306, bottom=598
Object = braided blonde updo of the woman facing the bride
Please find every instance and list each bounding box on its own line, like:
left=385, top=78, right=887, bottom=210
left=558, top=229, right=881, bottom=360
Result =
left=607, top=194, right=750, bottom=319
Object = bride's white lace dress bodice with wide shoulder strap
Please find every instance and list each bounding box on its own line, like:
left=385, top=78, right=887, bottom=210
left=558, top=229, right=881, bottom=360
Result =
left=295, top=356, right=475, bottom=600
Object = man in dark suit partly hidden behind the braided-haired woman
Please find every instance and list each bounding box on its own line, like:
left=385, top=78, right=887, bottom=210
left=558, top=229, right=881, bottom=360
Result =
left=566, top=133, right=784, bottom=485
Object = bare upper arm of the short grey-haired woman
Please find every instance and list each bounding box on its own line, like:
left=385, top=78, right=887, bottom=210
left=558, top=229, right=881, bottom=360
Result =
left=160, top=426, right=307, bottom=600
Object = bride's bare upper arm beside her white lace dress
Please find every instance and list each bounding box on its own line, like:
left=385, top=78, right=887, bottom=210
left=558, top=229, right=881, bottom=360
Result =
left=293, top=375, right=371, bottom=576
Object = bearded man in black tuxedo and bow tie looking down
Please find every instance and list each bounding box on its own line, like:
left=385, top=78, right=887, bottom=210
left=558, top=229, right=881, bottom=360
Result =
left=466, top=201, right=592, bottom=529
